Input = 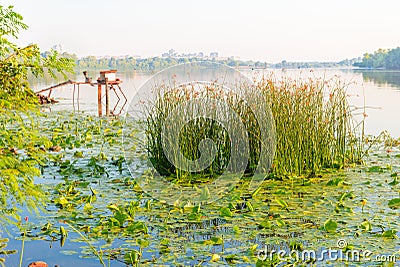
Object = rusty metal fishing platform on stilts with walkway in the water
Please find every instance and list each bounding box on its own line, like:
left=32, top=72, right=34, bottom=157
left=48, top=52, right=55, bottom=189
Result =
left=35, top=70, right=128, bottom=117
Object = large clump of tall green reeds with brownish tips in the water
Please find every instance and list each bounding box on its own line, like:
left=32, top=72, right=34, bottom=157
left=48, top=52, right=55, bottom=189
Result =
left=146, top=75, right=360, bottom=181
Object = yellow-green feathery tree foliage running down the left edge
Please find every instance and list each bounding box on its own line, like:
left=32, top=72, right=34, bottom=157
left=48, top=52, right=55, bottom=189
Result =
left=0, top=5, right=74, bottom=228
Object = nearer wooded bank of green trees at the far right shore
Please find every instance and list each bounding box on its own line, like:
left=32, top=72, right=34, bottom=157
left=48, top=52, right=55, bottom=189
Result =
left=354, top=47, right=400, bottom=70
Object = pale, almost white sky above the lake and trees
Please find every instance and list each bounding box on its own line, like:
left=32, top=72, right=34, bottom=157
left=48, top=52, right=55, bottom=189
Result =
left=1, top=0, right=400, bottom=63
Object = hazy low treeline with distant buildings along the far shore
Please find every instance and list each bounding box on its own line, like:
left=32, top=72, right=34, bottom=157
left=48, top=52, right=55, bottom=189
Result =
left=50, top=52, right=355, bottom=71
